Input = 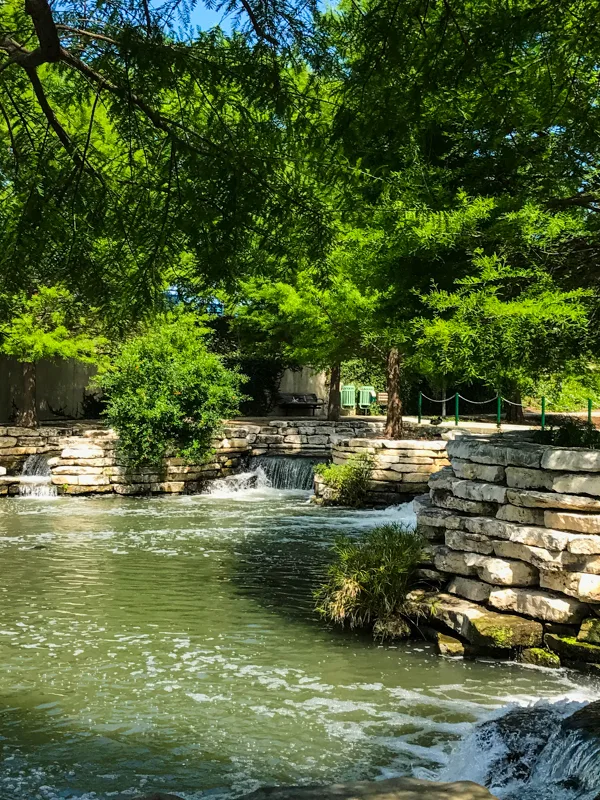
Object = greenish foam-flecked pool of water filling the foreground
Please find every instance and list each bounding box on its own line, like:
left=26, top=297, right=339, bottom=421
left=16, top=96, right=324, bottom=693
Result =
left=0, top=490, right=595, bottom=800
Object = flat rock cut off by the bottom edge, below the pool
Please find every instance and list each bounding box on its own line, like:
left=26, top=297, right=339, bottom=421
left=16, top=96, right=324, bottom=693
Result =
left=245, top=778, right=494, bottom=800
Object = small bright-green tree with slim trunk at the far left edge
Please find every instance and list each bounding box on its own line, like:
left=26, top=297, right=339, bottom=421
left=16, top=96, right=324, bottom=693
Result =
left=0, top=286, right=107, bottom=427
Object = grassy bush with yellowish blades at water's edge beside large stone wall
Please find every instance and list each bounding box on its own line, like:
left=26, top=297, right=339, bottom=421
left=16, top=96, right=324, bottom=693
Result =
left=315, top=524, right=423, bottom=628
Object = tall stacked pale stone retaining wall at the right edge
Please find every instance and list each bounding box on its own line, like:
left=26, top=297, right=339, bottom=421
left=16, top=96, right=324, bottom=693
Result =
left=417, top=436, right=600, bottom=664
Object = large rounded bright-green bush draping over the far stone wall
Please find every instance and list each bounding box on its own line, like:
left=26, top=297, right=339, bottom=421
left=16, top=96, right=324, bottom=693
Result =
left=97, top=312, right=244, bottom=467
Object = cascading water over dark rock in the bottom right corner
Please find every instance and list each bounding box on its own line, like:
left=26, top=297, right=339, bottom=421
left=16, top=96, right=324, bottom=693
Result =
left=438, top=700, right=600, bottom=800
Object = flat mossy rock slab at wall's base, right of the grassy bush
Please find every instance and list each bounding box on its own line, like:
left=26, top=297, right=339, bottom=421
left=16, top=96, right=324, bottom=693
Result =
left=430, top=594, right=543, bottom=650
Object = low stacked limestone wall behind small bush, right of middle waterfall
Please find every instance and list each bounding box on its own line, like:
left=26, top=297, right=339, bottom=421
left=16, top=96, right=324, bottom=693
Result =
left=315, top=434, right=450, bottom=505
